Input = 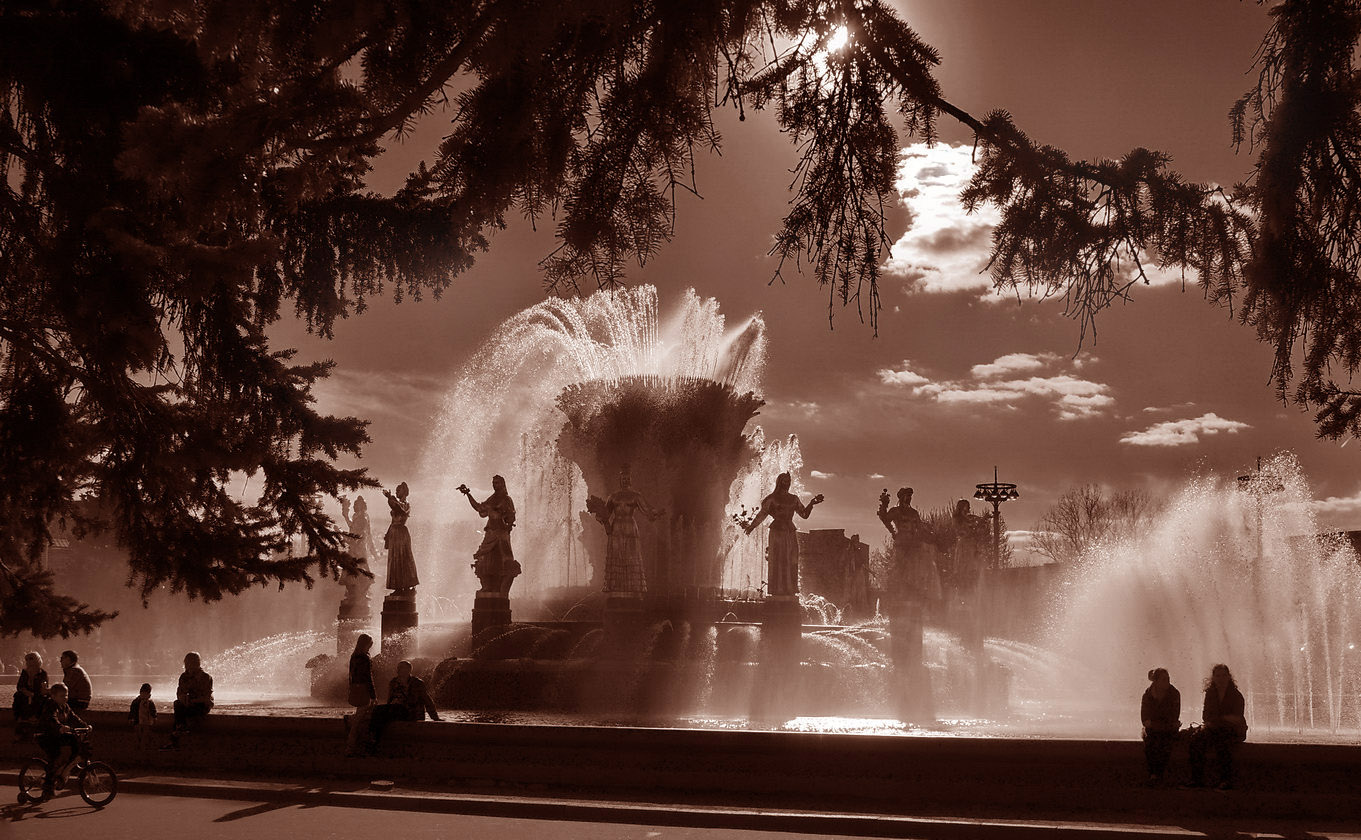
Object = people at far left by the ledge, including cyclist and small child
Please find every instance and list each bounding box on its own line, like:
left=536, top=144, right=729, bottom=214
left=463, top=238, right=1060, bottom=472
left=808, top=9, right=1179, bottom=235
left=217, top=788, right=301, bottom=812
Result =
left=11, top=651, right=212, bottom=756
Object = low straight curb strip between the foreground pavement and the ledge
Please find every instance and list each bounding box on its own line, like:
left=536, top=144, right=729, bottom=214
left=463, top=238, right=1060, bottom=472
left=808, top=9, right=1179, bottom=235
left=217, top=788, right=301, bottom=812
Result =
left=0, top=771, right=1361, bottom=840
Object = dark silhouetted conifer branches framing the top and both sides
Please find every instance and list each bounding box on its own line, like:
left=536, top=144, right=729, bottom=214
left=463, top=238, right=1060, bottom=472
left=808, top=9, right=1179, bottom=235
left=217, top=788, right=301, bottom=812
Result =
left=0, top=0, right=1361, bottom=632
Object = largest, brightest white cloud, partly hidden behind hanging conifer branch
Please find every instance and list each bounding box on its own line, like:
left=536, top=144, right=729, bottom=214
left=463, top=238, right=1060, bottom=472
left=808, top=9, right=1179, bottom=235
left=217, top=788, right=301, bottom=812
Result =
left=883, top=143, right=1184, bottom=301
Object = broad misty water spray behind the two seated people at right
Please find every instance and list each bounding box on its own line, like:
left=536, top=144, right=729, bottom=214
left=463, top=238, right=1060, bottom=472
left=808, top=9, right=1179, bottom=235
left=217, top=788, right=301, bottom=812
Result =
left=1048, top=455, right=1361, bottom=732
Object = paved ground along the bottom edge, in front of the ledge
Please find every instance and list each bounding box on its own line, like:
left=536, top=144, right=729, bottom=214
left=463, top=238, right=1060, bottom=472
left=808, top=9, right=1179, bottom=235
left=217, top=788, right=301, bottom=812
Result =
left=0, top=773, right=1361, bottom=840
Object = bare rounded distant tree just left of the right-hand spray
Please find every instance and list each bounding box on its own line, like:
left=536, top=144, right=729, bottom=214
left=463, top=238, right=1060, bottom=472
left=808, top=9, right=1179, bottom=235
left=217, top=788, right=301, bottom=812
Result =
left=1033, top=485, right=1158, bottom=564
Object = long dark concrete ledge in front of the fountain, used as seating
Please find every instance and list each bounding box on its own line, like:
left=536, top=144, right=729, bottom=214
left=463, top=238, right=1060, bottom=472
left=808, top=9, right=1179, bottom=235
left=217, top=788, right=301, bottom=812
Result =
left=0, top=712, right=1361, bottom=825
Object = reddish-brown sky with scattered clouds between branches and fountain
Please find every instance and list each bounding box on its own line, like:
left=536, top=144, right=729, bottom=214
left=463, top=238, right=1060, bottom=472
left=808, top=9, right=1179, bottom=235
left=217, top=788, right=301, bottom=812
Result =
left=274, top=0, right=1361, bottom=560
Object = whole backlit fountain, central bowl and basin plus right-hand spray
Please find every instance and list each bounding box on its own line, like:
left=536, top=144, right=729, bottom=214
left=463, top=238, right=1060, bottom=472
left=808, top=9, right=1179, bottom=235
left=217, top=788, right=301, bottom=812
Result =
left=289, top=287, right=1361, bottom=737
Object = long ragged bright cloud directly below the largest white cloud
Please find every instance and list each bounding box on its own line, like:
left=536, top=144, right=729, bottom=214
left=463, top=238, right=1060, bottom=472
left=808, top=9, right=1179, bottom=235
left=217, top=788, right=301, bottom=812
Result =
left=878, top=353, right=1115, bottom=421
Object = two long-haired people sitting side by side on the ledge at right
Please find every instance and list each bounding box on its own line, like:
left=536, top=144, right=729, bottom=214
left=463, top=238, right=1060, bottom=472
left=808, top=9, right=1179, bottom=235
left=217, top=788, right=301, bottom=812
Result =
left=1139, top=664, right=1248, bottom=790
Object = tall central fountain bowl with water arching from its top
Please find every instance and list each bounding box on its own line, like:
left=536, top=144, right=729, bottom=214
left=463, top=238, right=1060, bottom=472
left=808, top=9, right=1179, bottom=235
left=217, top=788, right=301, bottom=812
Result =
left=412, top=286, right=802, bottom=618
